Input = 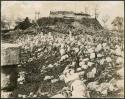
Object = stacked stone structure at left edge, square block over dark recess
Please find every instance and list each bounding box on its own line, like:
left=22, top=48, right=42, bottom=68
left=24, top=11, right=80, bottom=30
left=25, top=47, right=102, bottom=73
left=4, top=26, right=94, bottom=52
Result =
left=1, top=43, right=20, bottom=98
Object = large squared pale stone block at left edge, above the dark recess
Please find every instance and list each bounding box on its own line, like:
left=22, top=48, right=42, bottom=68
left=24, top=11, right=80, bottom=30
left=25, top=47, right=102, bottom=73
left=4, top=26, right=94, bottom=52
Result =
left=1, top=43, right=20, bottom=66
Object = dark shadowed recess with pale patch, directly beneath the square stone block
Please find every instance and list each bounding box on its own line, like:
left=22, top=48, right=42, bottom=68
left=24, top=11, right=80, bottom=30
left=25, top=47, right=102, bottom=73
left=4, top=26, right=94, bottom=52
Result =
left=1, top=66, right=17, bottom=90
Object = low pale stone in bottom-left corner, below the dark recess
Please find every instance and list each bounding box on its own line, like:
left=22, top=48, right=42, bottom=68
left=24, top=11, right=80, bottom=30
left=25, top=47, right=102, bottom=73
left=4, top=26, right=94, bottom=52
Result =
left=1, top=90, right=18, bottom=98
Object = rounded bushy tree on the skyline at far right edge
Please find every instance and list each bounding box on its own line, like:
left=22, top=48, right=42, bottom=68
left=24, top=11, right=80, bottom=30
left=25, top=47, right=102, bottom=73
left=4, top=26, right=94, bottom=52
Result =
left=111, top=16, right=123, bottom=32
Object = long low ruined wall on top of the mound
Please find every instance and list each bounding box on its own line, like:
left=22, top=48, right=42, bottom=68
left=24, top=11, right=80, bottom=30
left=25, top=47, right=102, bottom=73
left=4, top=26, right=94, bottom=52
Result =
left=50, top=11, right=90, bottom=19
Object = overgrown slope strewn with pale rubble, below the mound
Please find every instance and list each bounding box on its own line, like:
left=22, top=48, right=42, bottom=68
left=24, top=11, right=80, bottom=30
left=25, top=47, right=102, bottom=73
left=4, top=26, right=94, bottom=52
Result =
left=13, top=28, right=124, bottom=97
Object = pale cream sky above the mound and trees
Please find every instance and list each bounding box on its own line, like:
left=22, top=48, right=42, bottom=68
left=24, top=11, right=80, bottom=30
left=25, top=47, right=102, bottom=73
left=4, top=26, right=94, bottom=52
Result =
left=1, top=1, right=124, bottom=28
